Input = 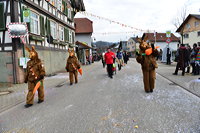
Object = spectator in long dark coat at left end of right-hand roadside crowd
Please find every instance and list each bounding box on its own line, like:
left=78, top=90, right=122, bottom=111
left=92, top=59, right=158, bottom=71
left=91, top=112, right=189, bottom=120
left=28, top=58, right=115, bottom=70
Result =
left=173, top=44, right=187, bottom=76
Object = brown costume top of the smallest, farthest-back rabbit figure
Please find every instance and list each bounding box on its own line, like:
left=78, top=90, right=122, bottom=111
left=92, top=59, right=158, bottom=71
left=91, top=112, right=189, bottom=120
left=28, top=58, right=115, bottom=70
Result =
left=65, top=56, right=80, bottom=72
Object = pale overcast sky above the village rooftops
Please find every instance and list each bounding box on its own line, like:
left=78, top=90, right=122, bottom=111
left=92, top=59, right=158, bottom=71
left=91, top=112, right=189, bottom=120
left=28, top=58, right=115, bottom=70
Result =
left=75, top=0, right=200, bottom=42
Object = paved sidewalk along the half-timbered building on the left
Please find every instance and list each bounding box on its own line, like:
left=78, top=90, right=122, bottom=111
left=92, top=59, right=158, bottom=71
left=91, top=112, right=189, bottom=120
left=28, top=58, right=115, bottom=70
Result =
left=0, top=64, right=95, bottom=113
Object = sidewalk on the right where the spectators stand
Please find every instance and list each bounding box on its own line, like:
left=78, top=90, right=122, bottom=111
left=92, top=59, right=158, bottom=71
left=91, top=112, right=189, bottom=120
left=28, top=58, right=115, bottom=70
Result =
left=156, top=62, right=200, bottom=97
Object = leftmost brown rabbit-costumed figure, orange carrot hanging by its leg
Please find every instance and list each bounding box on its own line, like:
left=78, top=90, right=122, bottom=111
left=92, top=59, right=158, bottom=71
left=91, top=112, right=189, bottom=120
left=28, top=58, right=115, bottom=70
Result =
left=25, top=46, right=45, bottom=108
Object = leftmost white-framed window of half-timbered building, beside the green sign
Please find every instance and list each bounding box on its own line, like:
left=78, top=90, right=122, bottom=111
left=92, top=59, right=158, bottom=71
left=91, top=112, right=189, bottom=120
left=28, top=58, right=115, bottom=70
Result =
left=30, top=11, right=40, bottom=34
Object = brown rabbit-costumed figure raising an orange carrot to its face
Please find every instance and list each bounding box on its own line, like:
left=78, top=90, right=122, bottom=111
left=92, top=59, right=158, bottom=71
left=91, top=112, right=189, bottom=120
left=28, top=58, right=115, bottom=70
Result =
left=136, top=36, right=159, bottom=93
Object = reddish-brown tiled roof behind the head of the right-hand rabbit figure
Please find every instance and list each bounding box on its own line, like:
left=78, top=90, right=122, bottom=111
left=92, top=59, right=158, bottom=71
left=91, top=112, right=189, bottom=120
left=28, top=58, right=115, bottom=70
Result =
left=143, top=33, right=179, bottom=42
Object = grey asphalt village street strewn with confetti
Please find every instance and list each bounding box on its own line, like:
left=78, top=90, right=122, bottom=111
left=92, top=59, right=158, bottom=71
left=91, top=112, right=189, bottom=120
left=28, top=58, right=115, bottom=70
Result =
left=0, top=59, right=200, bottom=133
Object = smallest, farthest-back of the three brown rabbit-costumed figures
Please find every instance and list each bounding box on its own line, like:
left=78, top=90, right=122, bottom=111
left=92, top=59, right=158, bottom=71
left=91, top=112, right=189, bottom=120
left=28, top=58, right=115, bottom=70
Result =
left=65, top=49, right=80, bottom=85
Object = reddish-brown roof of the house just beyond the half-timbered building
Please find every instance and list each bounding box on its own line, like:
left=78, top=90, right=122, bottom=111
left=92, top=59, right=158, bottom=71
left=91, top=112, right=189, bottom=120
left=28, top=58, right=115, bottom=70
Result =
left=74, top=18, right=93, bottom=34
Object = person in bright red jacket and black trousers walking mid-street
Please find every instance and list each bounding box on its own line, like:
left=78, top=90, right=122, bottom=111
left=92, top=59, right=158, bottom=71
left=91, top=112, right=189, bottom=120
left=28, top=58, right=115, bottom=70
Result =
left=104, top=48, right=115, bottom=78
